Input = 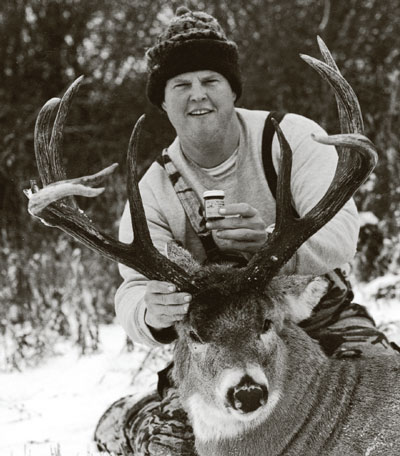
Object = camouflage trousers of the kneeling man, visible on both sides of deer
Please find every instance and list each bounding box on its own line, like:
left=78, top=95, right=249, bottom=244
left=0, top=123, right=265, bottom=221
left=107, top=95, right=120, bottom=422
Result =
left=95, top=271, right=396, bottom=456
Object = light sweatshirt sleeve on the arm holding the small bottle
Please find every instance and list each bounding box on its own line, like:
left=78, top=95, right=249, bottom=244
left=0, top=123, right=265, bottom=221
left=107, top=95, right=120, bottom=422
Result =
left=273, top=114, right=359, bottom=274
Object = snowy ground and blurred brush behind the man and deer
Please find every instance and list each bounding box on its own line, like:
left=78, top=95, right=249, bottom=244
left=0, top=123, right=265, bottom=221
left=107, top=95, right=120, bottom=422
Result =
left=0, top=0, right=400, bottom=456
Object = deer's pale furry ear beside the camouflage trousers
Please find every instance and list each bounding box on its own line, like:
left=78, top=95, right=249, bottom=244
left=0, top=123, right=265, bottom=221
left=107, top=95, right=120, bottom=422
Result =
left=268, top=275, right=329, bottom=323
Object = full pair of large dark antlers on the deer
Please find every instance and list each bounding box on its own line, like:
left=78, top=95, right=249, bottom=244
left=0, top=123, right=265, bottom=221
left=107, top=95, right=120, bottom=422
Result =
left=26, top=38, right=377, bottom=295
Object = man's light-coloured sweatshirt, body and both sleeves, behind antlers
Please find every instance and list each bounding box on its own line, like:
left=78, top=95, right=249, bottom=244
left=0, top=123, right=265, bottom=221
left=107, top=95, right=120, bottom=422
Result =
left=115, top=108, right=359, bottom=346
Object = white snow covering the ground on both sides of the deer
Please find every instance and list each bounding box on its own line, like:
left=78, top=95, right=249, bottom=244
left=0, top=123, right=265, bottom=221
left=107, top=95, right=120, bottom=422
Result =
left=0, top=276, right=400, bottom=456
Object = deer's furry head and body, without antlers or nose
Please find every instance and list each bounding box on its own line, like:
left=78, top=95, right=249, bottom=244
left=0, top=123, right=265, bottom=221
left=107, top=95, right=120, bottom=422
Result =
left=168, top=249, right=400, bottom=456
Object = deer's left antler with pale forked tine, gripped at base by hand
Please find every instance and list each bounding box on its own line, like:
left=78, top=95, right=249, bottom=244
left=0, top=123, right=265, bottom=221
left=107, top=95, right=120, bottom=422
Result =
left=25, top=77, right=201, bottom=293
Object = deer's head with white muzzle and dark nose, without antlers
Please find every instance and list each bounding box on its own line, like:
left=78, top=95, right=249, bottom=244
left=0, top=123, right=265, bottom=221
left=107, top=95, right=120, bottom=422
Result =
left=173, top=249, right=328, bottom=438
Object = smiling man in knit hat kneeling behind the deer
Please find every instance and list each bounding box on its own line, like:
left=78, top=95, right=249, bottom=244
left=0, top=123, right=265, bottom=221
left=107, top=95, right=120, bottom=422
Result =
left=96, top=8, right=394, bottom=454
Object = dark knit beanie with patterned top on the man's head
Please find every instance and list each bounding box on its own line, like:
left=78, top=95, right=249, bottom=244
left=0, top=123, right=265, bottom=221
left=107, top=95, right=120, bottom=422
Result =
left=146, top=6, right=242, bottom=108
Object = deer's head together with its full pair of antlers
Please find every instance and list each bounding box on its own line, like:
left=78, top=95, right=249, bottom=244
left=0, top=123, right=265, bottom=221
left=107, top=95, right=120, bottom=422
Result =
left=27, top=40, right=377, bottom=448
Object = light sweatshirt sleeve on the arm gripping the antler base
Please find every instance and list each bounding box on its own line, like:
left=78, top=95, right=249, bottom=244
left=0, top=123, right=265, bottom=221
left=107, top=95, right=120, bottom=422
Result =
left=115, top=169, right=178, bottom=347
